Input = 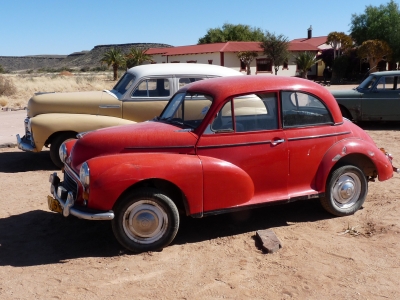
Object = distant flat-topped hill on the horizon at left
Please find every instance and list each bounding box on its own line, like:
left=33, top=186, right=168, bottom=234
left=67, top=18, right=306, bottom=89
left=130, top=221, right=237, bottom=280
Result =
left=0, top=43, right=172, bottom=72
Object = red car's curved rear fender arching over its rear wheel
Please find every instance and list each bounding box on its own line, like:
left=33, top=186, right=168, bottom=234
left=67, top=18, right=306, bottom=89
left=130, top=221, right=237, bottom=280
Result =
left=315, top=138, right=393, bottom=191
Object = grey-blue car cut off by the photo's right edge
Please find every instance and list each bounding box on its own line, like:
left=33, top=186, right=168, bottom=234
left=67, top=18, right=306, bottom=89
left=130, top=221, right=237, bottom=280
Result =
left=331, top=71, right=400, bottom=121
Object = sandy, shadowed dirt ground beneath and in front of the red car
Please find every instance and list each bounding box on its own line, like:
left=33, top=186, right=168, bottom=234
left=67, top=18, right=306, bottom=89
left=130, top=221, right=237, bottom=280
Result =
left=0, top=124, right=400, bottom=300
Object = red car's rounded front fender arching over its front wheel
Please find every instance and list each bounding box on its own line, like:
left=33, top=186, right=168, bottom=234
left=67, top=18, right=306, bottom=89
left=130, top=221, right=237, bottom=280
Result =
left=87, top=153, right=203, bottom=214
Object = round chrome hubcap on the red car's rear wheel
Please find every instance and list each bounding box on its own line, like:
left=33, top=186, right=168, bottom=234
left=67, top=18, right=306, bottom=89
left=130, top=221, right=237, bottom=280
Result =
left=332, top=173, right=361, bottom=208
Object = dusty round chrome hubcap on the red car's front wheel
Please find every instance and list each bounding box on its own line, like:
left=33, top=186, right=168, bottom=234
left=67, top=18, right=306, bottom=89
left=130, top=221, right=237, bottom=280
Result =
left=123, top=200, right=168, bottom=244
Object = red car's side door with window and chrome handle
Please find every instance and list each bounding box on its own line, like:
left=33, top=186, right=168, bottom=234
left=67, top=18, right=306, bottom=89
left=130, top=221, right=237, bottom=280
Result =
left=197, top=93, right=288, bottom=212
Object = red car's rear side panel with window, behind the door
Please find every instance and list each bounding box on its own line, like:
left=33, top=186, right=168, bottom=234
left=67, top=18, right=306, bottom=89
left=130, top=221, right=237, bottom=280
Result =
left=281, top=91, right=340, bottom=198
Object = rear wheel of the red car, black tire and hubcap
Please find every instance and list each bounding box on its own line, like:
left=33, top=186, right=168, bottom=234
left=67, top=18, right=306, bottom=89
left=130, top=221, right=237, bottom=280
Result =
left=320, top=165, right=368, bottom=217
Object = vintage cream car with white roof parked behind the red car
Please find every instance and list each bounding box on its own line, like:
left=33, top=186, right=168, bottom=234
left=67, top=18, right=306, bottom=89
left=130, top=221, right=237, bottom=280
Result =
left=17, top=63, right=241, bottom=167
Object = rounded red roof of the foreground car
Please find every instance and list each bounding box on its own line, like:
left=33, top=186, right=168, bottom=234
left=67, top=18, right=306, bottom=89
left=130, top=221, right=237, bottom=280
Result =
left=180, top=75, right=343, bottom=123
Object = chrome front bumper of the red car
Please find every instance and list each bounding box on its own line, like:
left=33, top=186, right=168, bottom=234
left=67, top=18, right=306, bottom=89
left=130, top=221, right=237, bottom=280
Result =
left=49, top=172, right=114, bottom=220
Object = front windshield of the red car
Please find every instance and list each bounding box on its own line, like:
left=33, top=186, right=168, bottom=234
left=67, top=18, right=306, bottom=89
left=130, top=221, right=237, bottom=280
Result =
left=158, top=93, right=213, bottom=129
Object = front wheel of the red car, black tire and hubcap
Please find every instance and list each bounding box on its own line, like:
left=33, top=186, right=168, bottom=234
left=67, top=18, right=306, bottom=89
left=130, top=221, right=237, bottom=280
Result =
left=111, top=188, right=179, bottom=253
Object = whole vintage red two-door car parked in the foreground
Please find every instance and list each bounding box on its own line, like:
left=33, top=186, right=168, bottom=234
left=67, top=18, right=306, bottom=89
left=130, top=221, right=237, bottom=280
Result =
left=48, top=76, right=397, bottom=252
